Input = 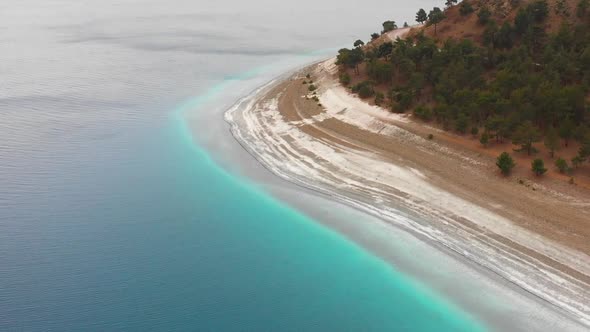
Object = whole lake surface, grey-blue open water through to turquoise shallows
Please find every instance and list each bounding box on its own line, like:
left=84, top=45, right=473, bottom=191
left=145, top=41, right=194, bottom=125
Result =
left=0, top=0, right=494, bottom=331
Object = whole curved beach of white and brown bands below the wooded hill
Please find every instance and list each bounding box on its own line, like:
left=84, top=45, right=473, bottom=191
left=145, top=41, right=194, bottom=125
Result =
left=226, top=51, right=590, bottom=323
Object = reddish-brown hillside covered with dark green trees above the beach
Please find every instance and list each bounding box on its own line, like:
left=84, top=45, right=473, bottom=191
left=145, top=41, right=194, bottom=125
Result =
left=337, top=0, right=590, bottom=182
